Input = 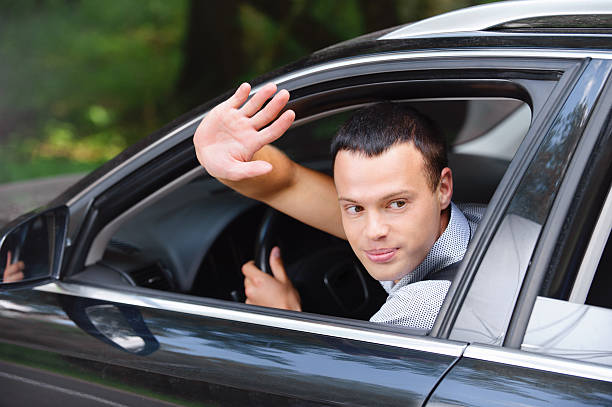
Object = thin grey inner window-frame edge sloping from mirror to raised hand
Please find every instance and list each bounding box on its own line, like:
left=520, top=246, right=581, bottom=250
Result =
left=85, top=167, right=206, bottom=267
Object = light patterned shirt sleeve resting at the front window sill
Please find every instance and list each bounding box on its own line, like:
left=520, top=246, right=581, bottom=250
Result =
left=370, top=280, right=451, bottom=329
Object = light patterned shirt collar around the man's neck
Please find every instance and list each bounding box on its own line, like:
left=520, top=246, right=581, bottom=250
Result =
left=381, top=202, right=471, bottom=293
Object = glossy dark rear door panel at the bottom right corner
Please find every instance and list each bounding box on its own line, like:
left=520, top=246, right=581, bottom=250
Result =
left=426, top=347, right=612, bottom=407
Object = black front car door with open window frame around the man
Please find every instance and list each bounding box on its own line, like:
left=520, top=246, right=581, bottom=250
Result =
left=0, top=51, right=588, bottom=405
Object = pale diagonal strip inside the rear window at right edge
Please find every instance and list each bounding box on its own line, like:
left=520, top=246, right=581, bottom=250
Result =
left=569, top=187, right=612, bottom=304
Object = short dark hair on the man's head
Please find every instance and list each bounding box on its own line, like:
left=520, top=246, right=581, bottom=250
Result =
left=331, top=102, right=448, bottom=190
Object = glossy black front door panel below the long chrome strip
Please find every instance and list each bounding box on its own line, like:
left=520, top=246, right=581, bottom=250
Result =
left=0, top=285, right=462, bottom=405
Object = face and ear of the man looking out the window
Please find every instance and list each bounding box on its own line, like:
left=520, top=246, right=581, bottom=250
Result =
left=334, top=142, right=452, bottom=281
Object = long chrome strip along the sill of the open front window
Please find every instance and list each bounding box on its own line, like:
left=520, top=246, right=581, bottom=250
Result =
left=35, top=282, right=466, bottom=357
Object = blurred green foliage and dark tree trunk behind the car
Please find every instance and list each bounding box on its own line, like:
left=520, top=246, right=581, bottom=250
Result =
left=0, top=0, right=489, bottom=182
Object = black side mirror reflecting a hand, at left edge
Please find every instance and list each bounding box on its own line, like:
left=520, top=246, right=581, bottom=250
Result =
left=0, top=206, right=68, bottom=286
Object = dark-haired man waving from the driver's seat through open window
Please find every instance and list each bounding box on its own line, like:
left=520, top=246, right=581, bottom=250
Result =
left=194, top=84, right=478, bottom=329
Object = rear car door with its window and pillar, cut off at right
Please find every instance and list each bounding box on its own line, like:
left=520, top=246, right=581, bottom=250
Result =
left=427, top=60, right=612, bottom=406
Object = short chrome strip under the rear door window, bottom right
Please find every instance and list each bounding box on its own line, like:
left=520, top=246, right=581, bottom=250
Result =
left=463, top=344, right=612, bottom=382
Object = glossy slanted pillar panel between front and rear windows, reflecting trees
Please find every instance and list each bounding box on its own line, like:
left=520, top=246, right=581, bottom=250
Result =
left=450, top=65, right=601, bottom=345
